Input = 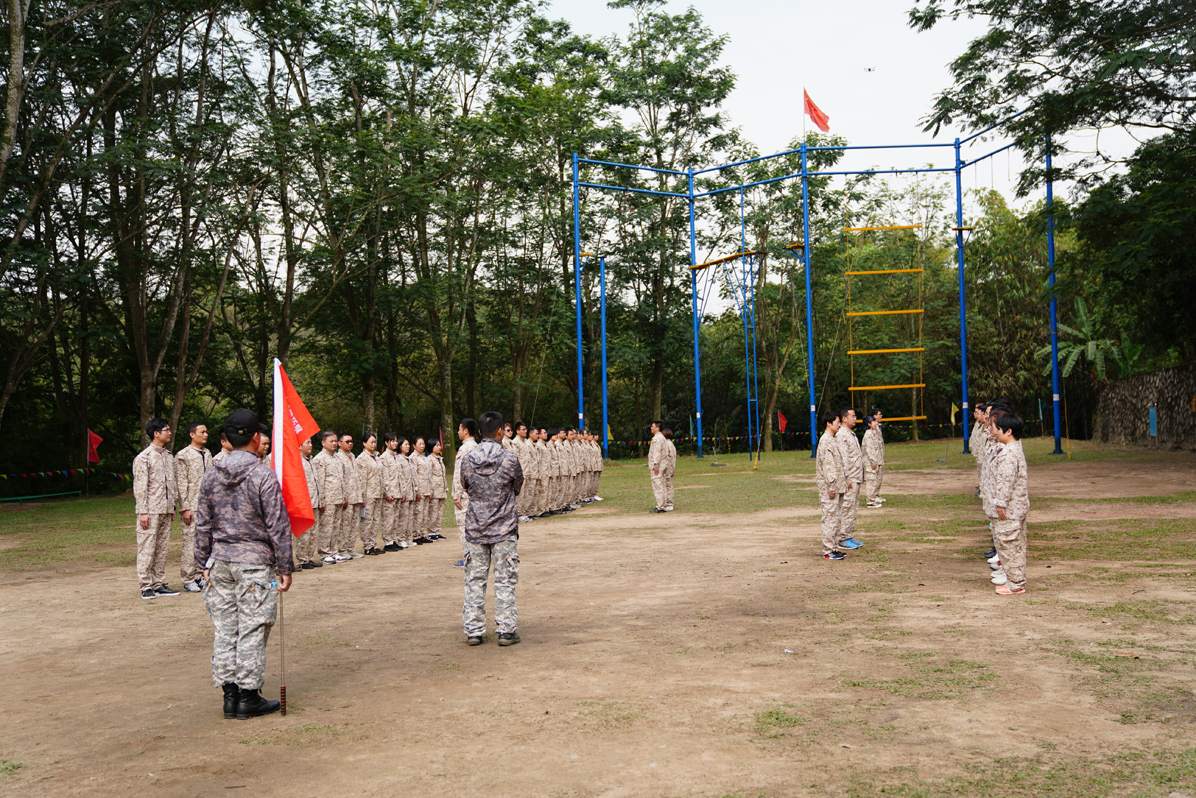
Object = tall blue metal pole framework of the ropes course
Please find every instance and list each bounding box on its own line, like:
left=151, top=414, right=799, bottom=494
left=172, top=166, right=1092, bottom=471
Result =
left=573, top=111, right=1062, bottom=458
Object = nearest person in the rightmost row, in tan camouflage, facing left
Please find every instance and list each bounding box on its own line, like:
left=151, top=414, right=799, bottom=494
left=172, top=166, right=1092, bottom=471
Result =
left=989, top=413, right=1030, bottom=596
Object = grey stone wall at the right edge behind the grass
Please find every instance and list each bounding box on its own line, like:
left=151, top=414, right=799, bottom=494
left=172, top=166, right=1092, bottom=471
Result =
left=1093, top=366, right=1196, bottom=451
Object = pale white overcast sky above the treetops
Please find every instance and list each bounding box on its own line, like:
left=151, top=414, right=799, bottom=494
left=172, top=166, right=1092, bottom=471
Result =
left=550, top=0, right=1133, bottom=211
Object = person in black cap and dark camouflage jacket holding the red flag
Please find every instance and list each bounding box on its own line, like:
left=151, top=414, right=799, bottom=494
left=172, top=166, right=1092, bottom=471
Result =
left=195, top=409, right=294, bottom=719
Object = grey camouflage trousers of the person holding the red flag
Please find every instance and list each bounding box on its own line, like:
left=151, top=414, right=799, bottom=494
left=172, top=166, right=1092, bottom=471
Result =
left=203, top=560, right=279, bottom=690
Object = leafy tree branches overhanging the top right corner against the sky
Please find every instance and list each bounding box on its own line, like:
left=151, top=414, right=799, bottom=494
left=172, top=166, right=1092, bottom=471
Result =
left=909, top=0, right=1196, bottom=191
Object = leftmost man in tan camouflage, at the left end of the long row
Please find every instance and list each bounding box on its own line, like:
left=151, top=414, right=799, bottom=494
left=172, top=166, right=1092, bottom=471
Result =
left=133, top=418, right=178, bottom=598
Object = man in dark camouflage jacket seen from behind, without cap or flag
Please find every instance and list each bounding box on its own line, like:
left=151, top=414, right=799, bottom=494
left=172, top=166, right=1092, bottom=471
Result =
left=457, top=410, right=523, bottom=646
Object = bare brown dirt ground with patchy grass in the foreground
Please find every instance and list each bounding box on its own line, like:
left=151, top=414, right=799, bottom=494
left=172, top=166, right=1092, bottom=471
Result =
left=0, top=447, right=1196, bottom=798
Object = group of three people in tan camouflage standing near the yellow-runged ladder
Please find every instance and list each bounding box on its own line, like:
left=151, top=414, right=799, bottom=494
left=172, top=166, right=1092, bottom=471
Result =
left=814, top=407, right=885, bottom=560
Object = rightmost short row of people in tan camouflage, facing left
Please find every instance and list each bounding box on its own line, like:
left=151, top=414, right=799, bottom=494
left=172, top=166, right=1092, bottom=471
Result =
left=968, top=400, right=1030, bottom=596
